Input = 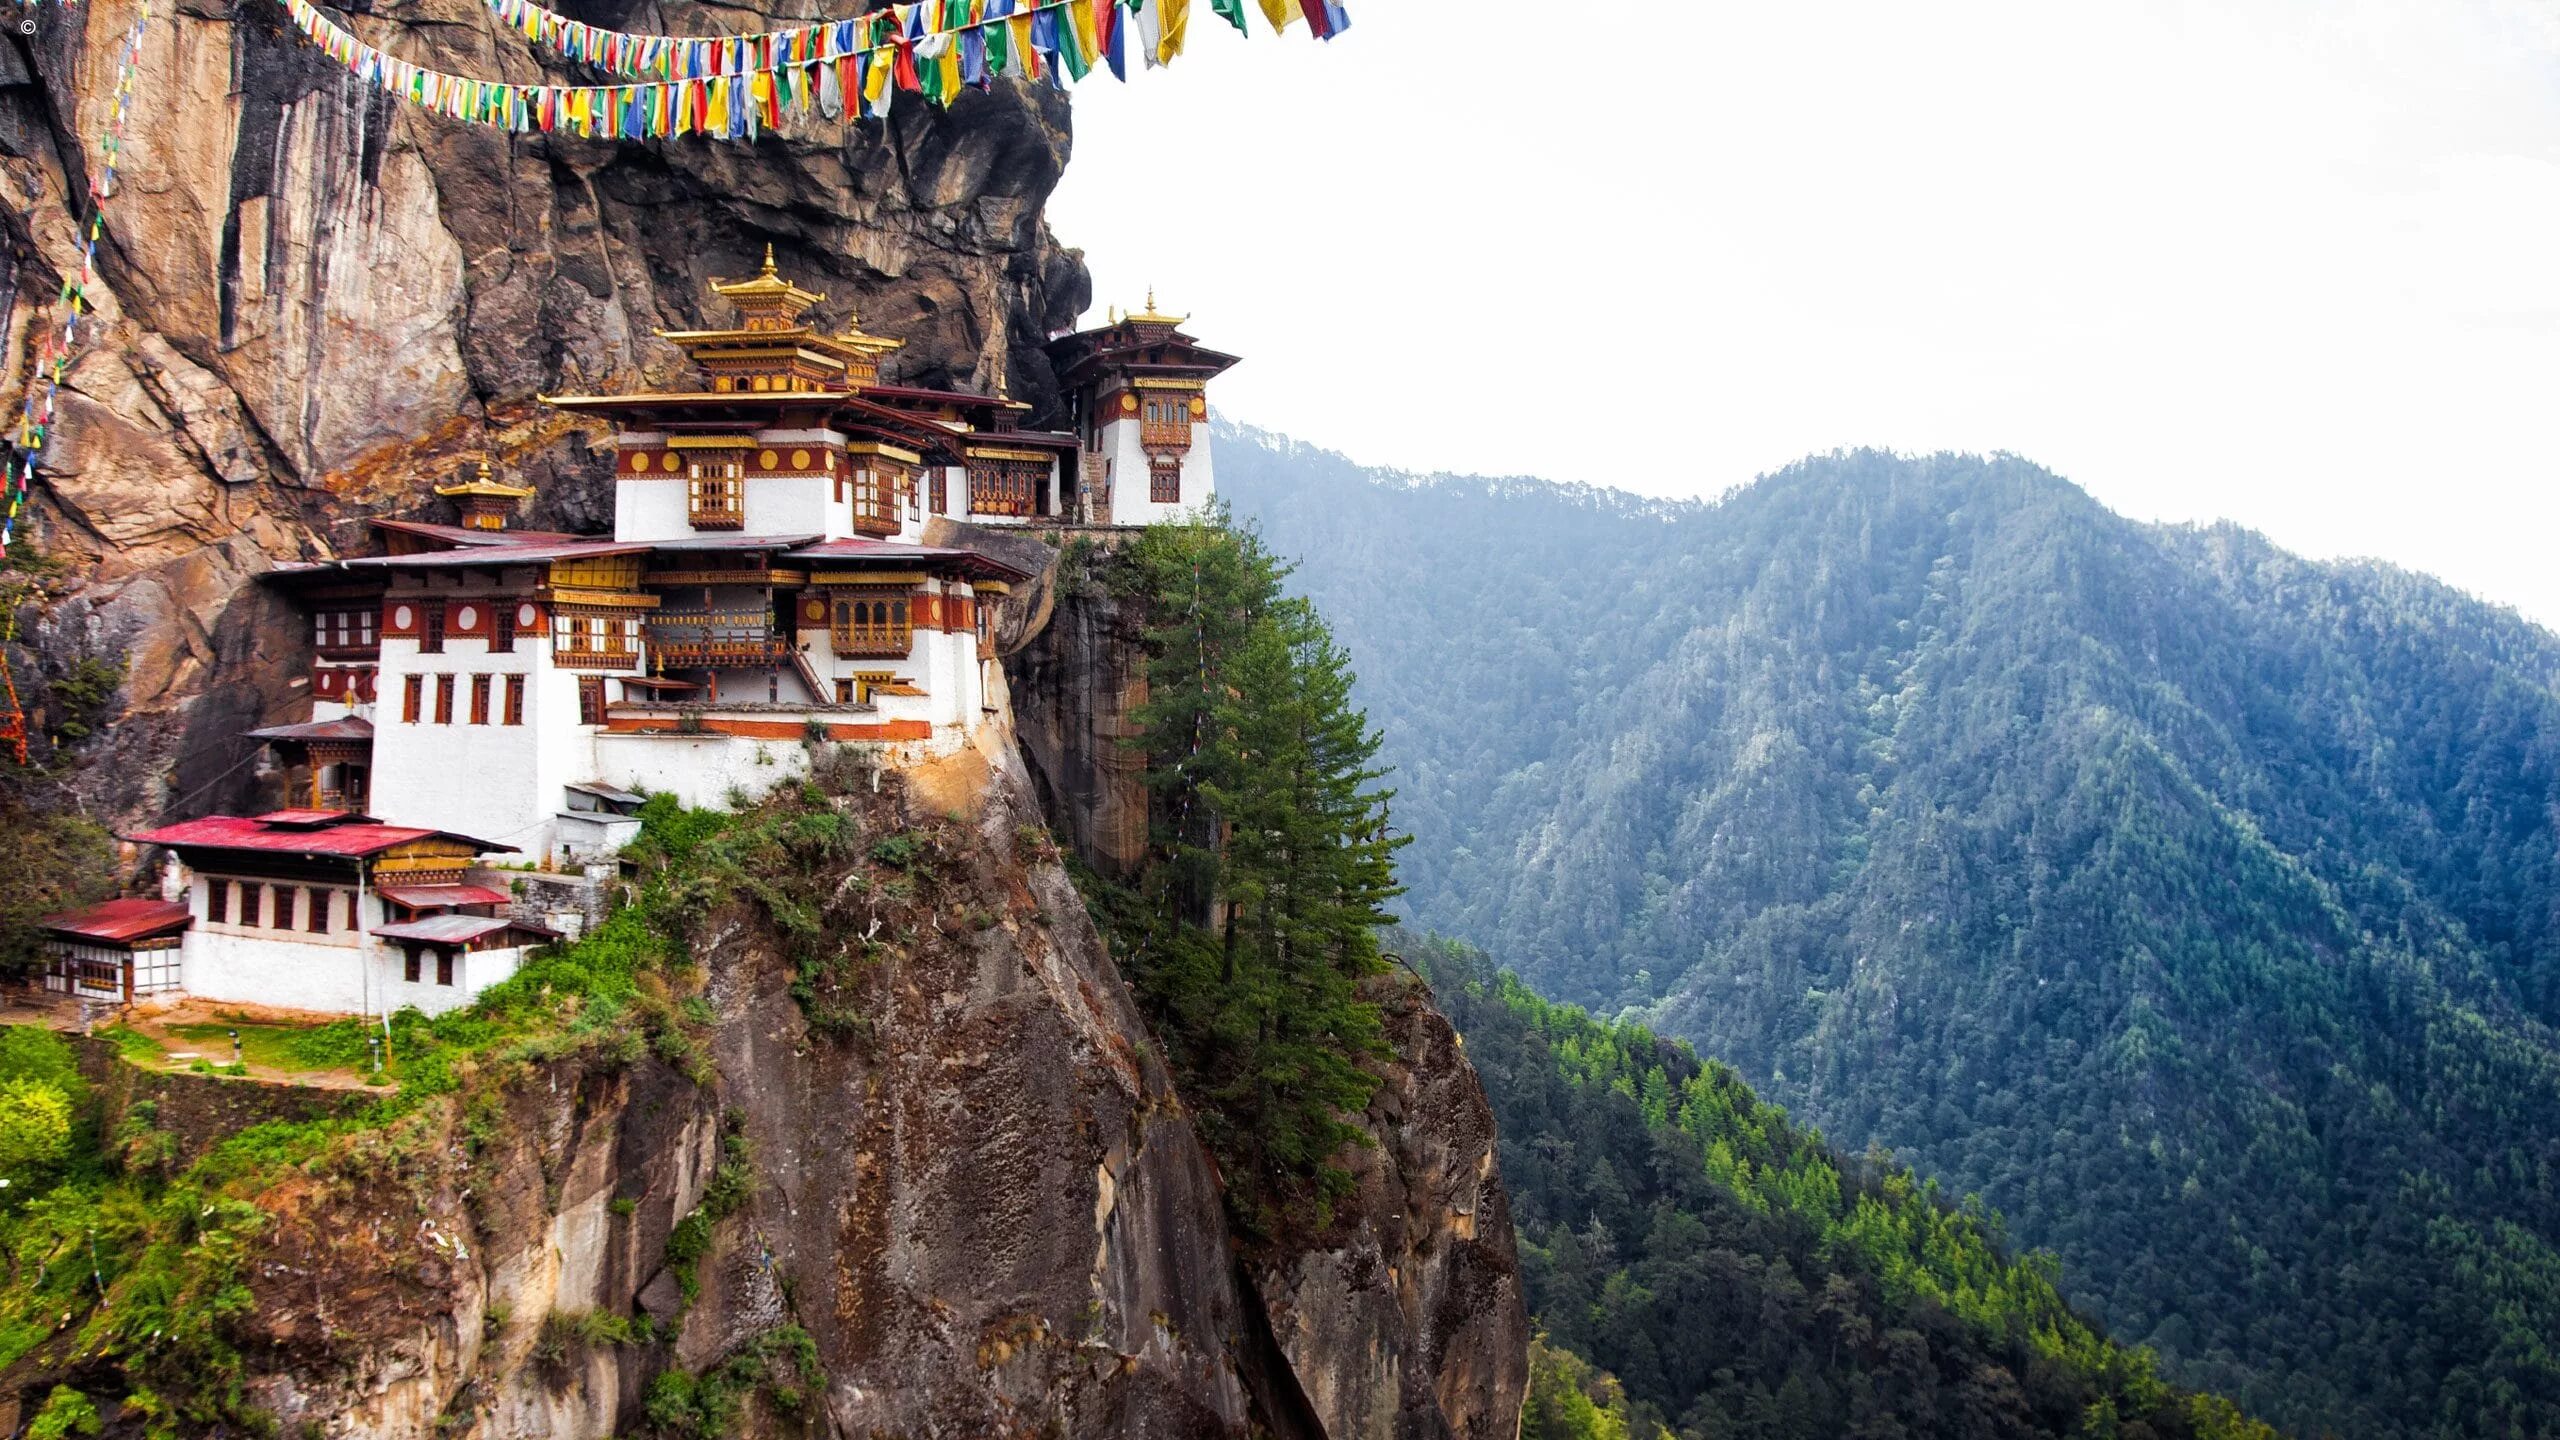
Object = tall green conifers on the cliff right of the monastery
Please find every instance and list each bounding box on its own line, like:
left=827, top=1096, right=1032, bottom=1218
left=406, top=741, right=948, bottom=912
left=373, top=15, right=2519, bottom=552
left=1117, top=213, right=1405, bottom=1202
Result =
left=1126, top=515, right=1403, bottom=1225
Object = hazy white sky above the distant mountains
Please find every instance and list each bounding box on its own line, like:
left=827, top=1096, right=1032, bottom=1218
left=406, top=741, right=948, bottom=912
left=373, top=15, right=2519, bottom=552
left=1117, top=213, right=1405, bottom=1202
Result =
left=1052, top=0, right=2560, bottom=625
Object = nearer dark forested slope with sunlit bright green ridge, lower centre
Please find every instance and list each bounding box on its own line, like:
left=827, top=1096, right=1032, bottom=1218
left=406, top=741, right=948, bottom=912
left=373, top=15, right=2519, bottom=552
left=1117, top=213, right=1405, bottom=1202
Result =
left=1403, top=935, right=2273, bottom=1440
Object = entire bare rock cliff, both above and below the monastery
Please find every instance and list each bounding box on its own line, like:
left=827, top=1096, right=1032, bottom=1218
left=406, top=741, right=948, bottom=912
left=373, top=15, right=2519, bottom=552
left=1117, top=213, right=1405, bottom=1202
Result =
left=0, top=11, right=1526, bottom=1440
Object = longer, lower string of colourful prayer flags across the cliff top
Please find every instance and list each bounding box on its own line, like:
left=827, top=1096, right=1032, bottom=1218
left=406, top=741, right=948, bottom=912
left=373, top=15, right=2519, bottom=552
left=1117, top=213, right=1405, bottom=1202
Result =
left=284, top=0, right=1349, bottom=141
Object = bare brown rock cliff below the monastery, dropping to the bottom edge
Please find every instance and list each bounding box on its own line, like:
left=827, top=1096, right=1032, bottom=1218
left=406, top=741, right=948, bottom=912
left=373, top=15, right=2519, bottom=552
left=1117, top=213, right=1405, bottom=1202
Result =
left=215, top=732, right=1526, bottom=1440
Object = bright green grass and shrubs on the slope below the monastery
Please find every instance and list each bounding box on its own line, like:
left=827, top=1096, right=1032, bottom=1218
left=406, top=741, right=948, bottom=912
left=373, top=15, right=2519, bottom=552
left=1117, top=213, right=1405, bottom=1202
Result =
left=0, top=799, right=753, bottom=1435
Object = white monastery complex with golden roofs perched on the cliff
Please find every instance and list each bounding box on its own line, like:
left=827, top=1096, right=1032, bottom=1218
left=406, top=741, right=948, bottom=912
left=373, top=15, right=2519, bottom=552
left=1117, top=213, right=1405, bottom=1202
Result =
left=46, top=260, right=1236, bottom=1015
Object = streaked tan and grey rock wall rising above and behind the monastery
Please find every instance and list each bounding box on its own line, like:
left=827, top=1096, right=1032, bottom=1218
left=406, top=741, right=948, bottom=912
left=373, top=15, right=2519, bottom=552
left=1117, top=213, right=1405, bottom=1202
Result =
left=0, top=0, right=1088, bottom=820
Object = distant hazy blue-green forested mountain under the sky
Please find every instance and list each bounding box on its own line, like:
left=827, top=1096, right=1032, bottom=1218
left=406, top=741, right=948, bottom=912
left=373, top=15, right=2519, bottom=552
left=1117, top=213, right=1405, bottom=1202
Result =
left=1219, top=433, right=2560, bottom=1435
